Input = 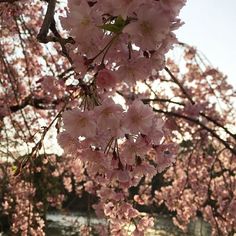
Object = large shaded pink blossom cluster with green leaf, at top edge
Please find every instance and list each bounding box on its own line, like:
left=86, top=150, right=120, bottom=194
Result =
left=61, top=0, right=185, bottom=83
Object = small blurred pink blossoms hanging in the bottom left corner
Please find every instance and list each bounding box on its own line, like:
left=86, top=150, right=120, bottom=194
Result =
left=2, top=169, right=45, bottom=236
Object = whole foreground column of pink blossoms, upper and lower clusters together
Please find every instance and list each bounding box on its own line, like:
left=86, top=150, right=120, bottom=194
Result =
left=58, top=0, right=185, bottom=234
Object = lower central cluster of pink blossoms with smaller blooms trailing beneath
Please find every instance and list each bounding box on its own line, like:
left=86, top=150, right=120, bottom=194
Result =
left=58, top=98, right=176, bottom=232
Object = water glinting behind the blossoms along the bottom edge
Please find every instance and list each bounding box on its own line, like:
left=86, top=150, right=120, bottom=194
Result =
left=46, top=213, right=211, bottom=236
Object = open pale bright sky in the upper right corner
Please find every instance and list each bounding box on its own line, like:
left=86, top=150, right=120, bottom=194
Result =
left=176, top=0, right=236, bottom=88
